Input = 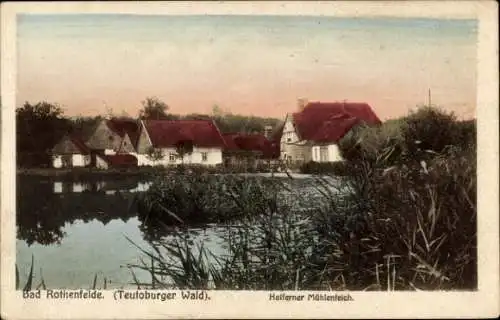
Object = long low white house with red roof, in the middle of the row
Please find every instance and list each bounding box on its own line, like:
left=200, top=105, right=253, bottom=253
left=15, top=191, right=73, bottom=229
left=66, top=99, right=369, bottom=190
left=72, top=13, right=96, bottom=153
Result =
left=131, top=120, right=226, bottom=166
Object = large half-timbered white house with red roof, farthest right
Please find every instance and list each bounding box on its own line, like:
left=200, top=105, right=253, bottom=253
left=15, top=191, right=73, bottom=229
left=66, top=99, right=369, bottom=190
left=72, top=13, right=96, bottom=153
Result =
left=280, top=102, right=381, bottom=162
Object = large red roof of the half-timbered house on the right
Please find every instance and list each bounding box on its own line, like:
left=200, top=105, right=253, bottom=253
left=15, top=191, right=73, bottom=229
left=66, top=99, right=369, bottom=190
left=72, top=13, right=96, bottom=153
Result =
left=292, top=102, right=381, bottom=142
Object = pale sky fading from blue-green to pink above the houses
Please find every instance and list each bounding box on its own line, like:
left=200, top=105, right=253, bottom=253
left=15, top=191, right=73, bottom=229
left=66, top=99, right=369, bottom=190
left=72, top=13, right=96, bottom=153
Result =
left=17, top=14, right=477, bottom=119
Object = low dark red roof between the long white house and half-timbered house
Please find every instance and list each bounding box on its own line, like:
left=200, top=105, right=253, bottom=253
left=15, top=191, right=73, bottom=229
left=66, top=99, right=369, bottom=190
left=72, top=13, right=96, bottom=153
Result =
left=224, top=133, right=279, bottom=158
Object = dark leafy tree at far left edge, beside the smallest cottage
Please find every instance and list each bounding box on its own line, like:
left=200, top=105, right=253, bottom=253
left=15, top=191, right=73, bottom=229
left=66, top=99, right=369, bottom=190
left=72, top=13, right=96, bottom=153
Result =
left=16, top=102, right=71, bottom=167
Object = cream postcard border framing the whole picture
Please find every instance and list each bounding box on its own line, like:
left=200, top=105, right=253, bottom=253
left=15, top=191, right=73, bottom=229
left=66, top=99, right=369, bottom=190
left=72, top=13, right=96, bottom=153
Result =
left=0, top=1, right=499, bottom=319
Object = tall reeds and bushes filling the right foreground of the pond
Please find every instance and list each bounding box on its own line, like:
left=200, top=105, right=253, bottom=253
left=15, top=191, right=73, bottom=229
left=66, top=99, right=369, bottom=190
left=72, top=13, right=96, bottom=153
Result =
left=131, top=107, right=477, bottom=290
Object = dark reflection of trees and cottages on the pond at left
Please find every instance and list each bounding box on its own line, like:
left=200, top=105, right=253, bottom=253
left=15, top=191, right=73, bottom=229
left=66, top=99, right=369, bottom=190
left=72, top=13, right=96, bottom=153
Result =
left=16, top=177, right=147, bottom=245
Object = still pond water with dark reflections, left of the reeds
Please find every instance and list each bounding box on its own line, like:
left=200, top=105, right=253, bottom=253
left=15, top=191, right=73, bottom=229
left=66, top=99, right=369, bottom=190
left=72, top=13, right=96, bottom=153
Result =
left=16, top=176, right=344, bottom=289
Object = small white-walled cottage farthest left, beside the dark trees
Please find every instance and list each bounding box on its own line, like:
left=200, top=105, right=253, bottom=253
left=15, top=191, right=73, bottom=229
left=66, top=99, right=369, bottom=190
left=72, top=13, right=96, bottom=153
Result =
left=52, top=135, right=91, bottom=168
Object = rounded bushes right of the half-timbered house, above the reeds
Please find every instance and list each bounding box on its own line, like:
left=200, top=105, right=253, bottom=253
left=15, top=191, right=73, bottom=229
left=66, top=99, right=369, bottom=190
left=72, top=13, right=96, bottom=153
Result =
left=339, top=107, right=476, bottom=168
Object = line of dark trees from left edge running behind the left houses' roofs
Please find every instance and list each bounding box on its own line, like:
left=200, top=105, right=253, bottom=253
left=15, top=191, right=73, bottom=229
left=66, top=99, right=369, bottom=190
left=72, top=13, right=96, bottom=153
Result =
left=16, top=97, right=280, bottom=167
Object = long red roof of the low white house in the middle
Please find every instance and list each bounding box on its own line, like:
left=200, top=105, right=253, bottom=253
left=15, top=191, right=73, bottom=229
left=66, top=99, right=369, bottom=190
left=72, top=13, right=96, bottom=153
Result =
left=143, top=120, right=226, bottom=148
